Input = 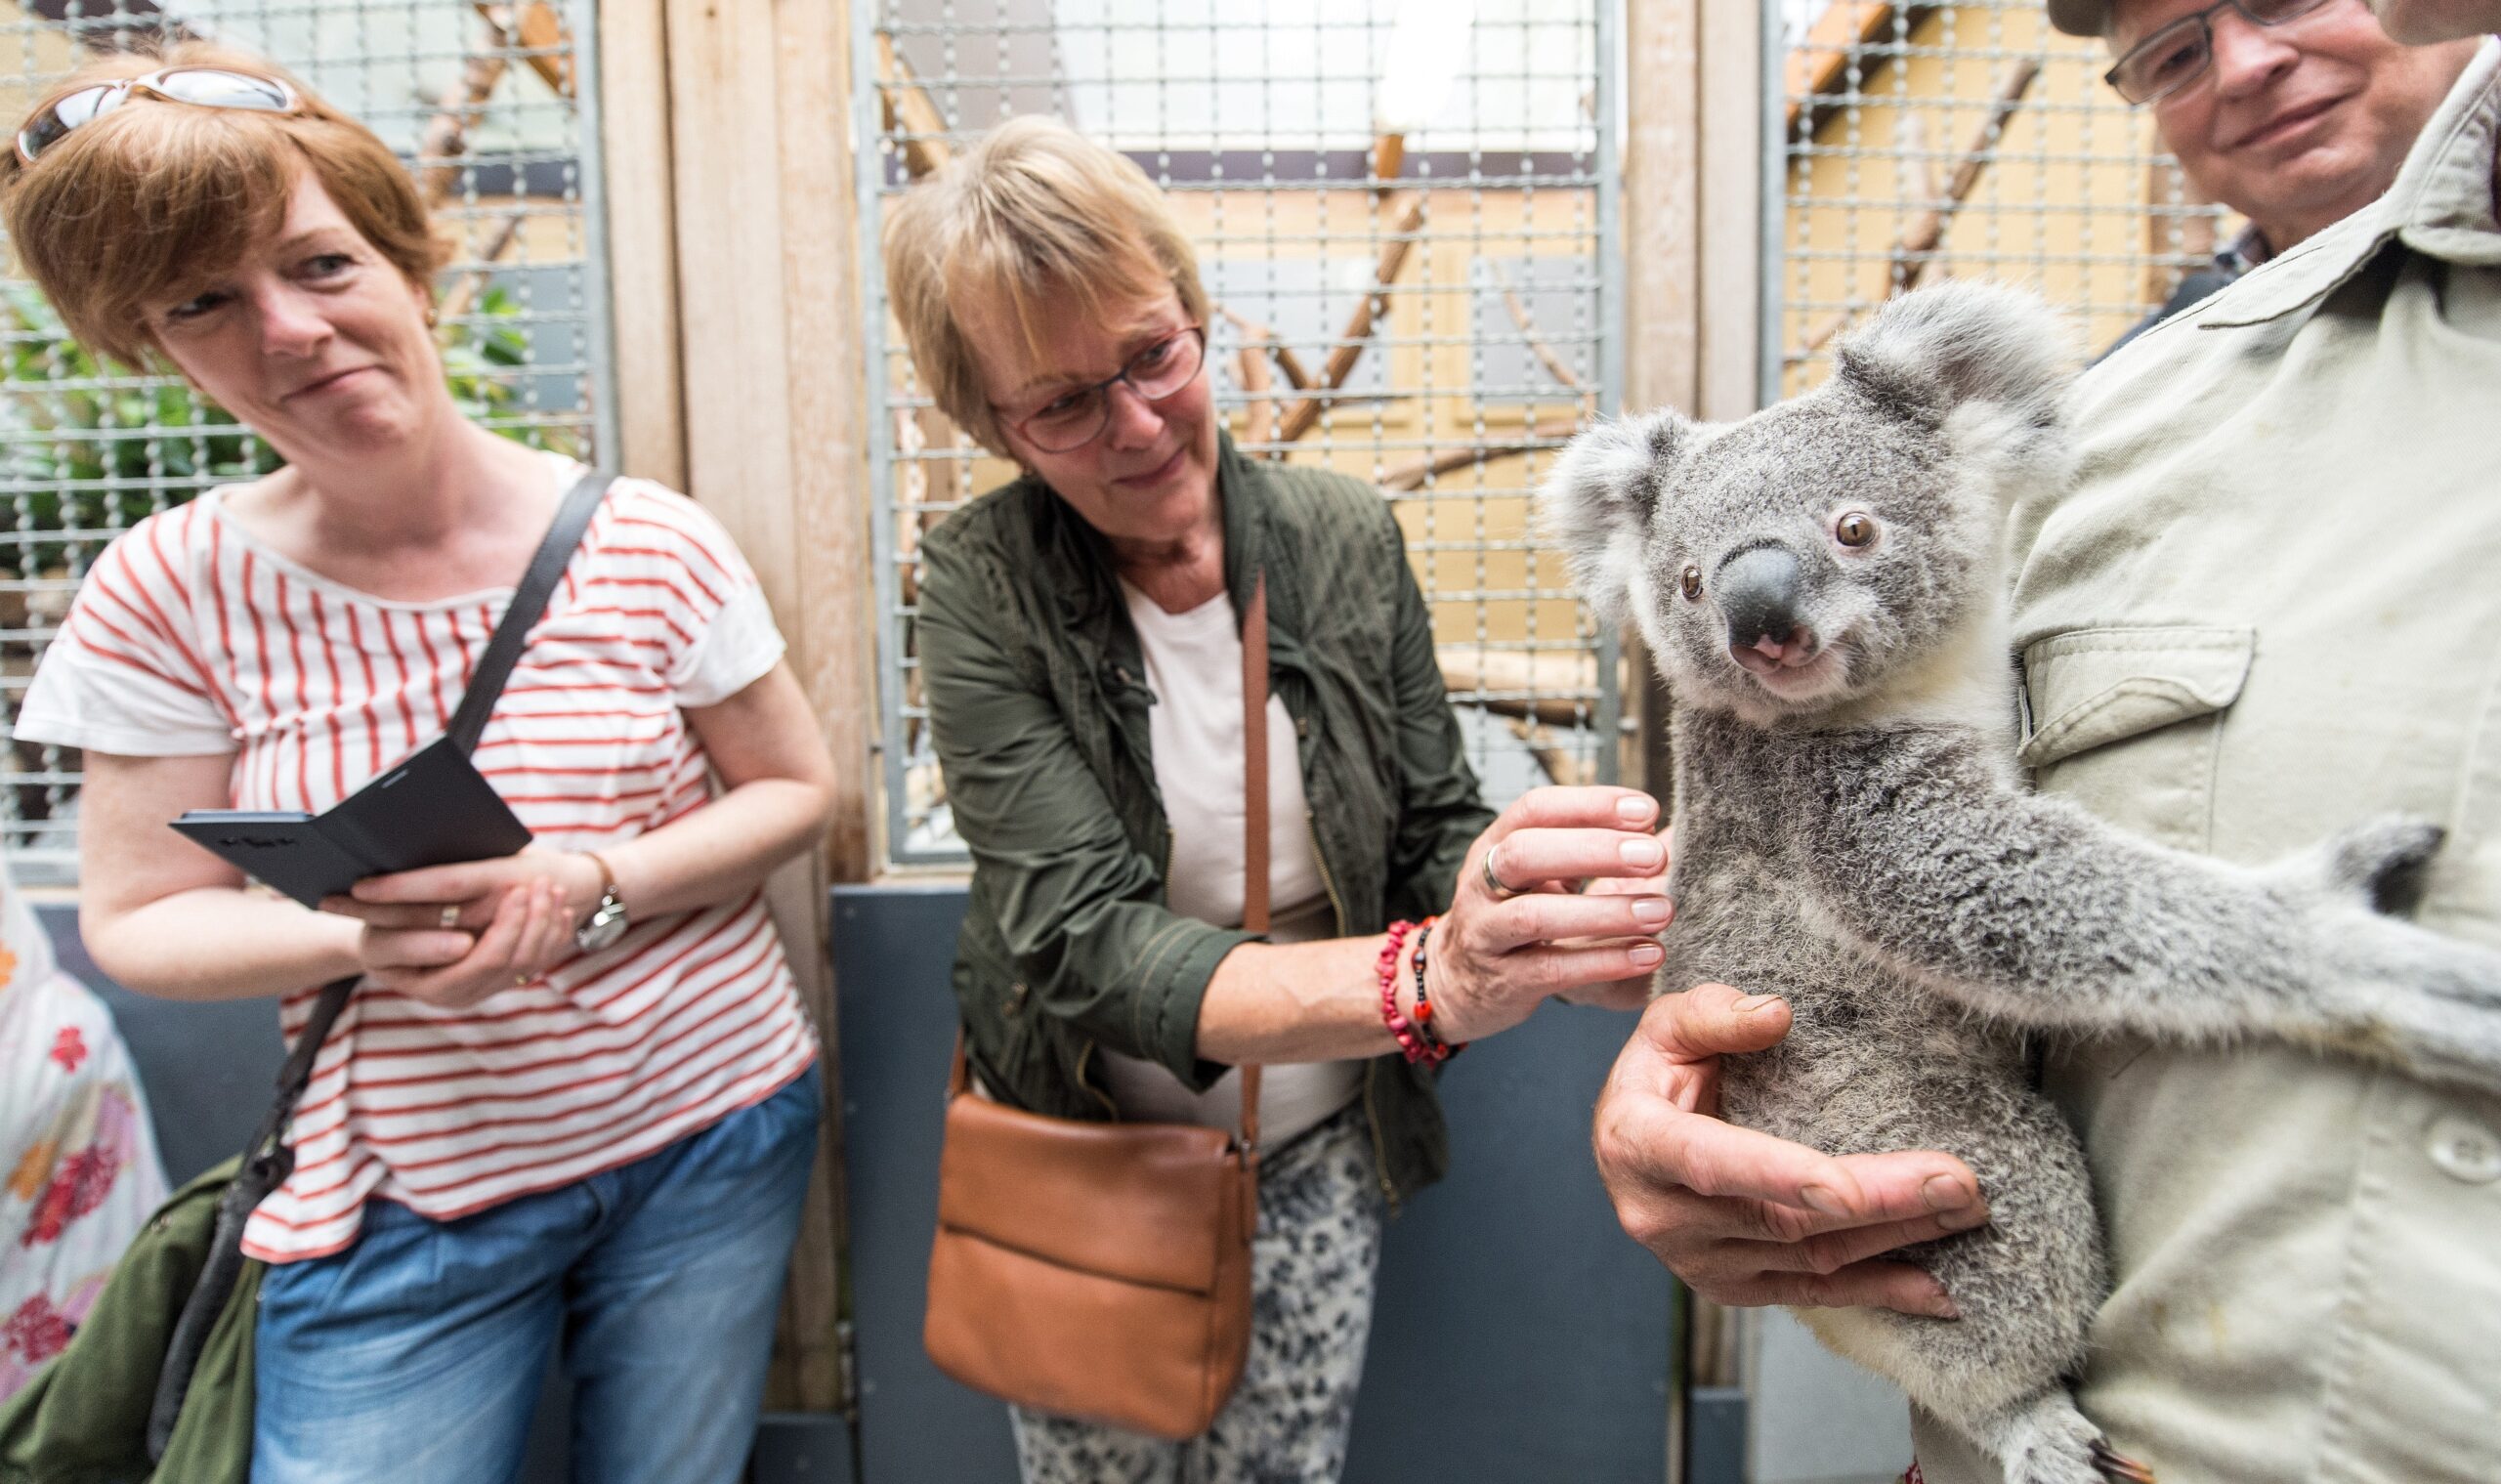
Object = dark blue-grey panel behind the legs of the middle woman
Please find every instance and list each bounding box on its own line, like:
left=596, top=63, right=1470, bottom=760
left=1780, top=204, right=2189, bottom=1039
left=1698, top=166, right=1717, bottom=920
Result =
left=832, top=883, right=1669, bottom=1484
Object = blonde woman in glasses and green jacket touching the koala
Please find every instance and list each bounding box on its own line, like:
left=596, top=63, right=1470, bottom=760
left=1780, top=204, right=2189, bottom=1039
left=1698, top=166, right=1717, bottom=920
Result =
left=885, top=117, right=1669, bottom=1484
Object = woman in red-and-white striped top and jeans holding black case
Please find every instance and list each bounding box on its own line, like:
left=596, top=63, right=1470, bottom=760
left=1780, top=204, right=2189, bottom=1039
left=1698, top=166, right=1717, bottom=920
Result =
left=0, top=48, right=830, bottom=1484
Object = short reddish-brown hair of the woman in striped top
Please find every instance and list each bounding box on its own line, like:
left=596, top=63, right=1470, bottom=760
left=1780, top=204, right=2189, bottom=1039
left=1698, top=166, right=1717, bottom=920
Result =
left=0, top=43, right=452, bottom=365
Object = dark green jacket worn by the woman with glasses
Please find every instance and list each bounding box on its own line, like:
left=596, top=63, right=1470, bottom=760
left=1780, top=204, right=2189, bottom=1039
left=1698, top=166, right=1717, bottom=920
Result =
left=918, top=438, right=1493, bottom=1202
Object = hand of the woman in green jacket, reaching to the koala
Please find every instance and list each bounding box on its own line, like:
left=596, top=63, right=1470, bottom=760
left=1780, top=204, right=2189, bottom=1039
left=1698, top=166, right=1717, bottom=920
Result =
left=1425, top=788, right=1675, bottom=1041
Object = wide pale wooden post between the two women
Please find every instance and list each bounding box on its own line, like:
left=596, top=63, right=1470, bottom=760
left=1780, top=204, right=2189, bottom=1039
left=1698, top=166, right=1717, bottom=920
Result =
left=640, top=0, right=872, bottom=1412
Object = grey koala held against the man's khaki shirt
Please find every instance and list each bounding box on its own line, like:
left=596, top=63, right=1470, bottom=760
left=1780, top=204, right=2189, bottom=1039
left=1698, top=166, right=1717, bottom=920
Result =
left=1538, top=282, right=2501, bottom=1484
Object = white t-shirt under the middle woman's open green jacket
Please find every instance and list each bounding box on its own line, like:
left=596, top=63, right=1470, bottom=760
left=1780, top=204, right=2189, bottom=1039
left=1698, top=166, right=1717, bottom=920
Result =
left=1103, top=583, right=1363, bottom=1149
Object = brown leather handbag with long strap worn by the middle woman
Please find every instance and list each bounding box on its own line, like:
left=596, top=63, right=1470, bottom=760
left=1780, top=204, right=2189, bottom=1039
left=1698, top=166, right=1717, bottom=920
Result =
left=920, top=578, right=1268, bottom=1439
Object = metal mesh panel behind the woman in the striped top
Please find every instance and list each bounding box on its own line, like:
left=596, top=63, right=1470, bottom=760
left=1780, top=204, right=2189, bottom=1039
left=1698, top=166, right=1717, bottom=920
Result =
left=0, top=0, right=613, bottom=881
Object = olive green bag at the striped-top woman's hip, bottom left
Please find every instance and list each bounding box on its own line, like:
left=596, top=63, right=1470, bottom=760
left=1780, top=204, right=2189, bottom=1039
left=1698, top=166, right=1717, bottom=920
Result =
left=0, top=1159, right=263, bottom=1484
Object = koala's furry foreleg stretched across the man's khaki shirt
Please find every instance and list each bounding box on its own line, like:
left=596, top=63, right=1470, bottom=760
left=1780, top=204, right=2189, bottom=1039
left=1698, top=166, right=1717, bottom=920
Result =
left=1768, top=734, right=2501, bottom=1086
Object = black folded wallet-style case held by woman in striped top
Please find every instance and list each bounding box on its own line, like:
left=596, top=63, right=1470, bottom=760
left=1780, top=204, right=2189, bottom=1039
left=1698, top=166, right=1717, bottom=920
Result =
left=173, top=736, right=530, bottom=906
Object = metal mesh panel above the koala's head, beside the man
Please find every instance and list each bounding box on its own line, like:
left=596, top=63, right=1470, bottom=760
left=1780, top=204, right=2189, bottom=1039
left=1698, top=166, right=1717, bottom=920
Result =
left=1765, top=0, right=2231, bottom=396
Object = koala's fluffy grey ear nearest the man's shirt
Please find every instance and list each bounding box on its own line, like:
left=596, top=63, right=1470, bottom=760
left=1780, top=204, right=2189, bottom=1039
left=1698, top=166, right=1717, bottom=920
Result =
left=1839, top=280, right=2076, bottom=428
